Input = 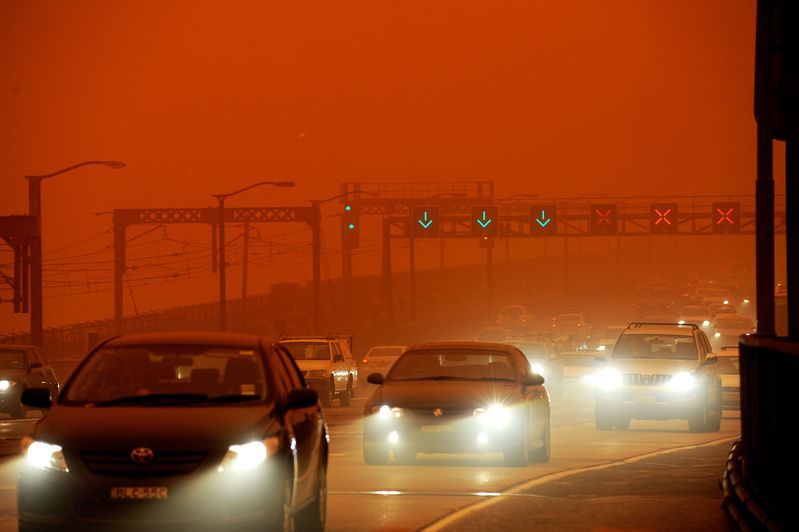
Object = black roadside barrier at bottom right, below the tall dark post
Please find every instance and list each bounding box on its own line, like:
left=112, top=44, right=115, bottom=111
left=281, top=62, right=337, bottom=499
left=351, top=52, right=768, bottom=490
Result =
left=736, top=335, right=799, bottom=530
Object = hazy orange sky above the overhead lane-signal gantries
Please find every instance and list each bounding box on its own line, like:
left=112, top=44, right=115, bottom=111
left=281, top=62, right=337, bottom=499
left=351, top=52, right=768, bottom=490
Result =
left=0, top=0, right=755, bottom=332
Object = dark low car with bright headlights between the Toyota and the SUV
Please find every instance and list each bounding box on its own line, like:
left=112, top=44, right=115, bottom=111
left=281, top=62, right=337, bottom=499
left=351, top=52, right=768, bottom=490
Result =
left=363, top=342, right=550, bottom=466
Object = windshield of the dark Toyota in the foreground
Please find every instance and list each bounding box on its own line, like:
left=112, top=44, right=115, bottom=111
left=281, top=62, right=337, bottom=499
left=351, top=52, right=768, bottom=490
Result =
left=65, top=345, right=268, bottom=406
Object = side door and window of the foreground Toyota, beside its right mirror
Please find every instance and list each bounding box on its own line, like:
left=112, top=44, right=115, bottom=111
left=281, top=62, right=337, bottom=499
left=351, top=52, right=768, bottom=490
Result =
left=273, top=346, right=324, bottom=504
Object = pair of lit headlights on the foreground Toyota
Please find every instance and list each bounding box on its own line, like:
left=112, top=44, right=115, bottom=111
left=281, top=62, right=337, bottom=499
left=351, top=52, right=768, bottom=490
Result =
left=22, top=436, right=280, bottom=473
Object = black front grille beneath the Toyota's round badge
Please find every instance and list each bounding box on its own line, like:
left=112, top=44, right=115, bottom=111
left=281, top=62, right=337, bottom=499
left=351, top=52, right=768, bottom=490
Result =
left=80, top=451, right=206, bottom=477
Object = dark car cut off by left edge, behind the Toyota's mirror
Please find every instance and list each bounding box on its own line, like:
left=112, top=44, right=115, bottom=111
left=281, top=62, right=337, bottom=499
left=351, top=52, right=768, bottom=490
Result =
left=0, top=345, right=61, bottom=419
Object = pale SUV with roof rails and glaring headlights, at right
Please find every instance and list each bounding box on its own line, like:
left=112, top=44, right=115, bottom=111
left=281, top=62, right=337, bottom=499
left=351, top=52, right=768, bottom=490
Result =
left=594, top=322, right=722, bottom=432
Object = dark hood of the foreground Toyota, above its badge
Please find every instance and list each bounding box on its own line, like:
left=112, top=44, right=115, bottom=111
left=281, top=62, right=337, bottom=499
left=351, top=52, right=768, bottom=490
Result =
left=33, top=405, right=277, bottom=447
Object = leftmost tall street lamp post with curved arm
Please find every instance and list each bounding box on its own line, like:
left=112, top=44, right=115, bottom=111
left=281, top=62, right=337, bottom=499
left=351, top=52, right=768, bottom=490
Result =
left=25, top=161, right=126, bottom=347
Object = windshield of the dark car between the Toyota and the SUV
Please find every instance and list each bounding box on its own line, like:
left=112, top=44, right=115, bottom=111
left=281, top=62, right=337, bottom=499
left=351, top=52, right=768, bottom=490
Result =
left=387, top=349, right=516, bottom=381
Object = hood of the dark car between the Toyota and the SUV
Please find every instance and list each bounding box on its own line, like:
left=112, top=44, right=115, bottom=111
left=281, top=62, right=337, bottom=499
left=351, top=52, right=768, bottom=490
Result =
left=366, top=381, right=521, bottom=408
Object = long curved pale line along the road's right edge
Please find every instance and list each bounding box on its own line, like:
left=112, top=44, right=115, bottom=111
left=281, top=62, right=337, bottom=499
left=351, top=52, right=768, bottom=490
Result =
left=421, top=435, right=740, bottom=532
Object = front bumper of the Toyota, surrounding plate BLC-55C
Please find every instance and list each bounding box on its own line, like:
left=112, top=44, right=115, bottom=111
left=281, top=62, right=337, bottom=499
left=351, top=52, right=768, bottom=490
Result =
left=17, top=463, right=283, bottom=530
